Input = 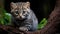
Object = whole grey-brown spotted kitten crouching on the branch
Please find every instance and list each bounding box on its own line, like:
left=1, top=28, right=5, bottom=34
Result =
left=10, top=2, right=38, bottom=31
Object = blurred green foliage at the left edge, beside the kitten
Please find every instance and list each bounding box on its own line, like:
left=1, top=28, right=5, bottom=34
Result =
left=0, top=8, right=11, bottom=25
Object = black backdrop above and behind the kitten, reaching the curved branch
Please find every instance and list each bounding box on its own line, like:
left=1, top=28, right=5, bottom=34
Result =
left=5, top=0, right=56, bottom=22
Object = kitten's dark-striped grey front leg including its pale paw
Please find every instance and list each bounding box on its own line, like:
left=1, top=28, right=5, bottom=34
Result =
left=19, top=19, right=32, bottom=31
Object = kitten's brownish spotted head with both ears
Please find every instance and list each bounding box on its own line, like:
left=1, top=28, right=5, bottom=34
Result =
left=10, top=2, right=30, bottom=20
